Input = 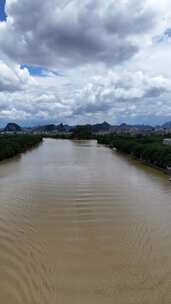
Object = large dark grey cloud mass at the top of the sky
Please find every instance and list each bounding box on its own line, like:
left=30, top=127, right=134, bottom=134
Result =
left=0, top=0, right=154, bottom=66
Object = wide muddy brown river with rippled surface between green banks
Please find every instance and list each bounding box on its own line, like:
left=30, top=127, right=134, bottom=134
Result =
left=0, top=139, right=171, bottom=304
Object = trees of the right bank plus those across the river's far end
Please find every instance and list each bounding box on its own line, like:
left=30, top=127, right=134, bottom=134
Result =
left=47, top=126, right=171, bottom=170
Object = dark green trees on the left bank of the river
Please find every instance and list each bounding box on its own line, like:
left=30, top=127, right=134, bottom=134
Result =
left=0, top=135, right=42, bottom=161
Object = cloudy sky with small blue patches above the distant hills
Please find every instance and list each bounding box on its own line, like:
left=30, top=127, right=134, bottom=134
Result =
left=0, top=0, right=171, bottom=126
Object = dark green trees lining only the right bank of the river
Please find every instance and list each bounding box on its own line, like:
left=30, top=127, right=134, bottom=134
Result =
left=97, top=134, right=171, bottom=169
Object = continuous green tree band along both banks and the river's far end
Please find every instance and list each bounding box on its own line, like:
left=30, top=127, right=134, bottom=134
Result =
left=0, top=126, right=171, bottom=170
